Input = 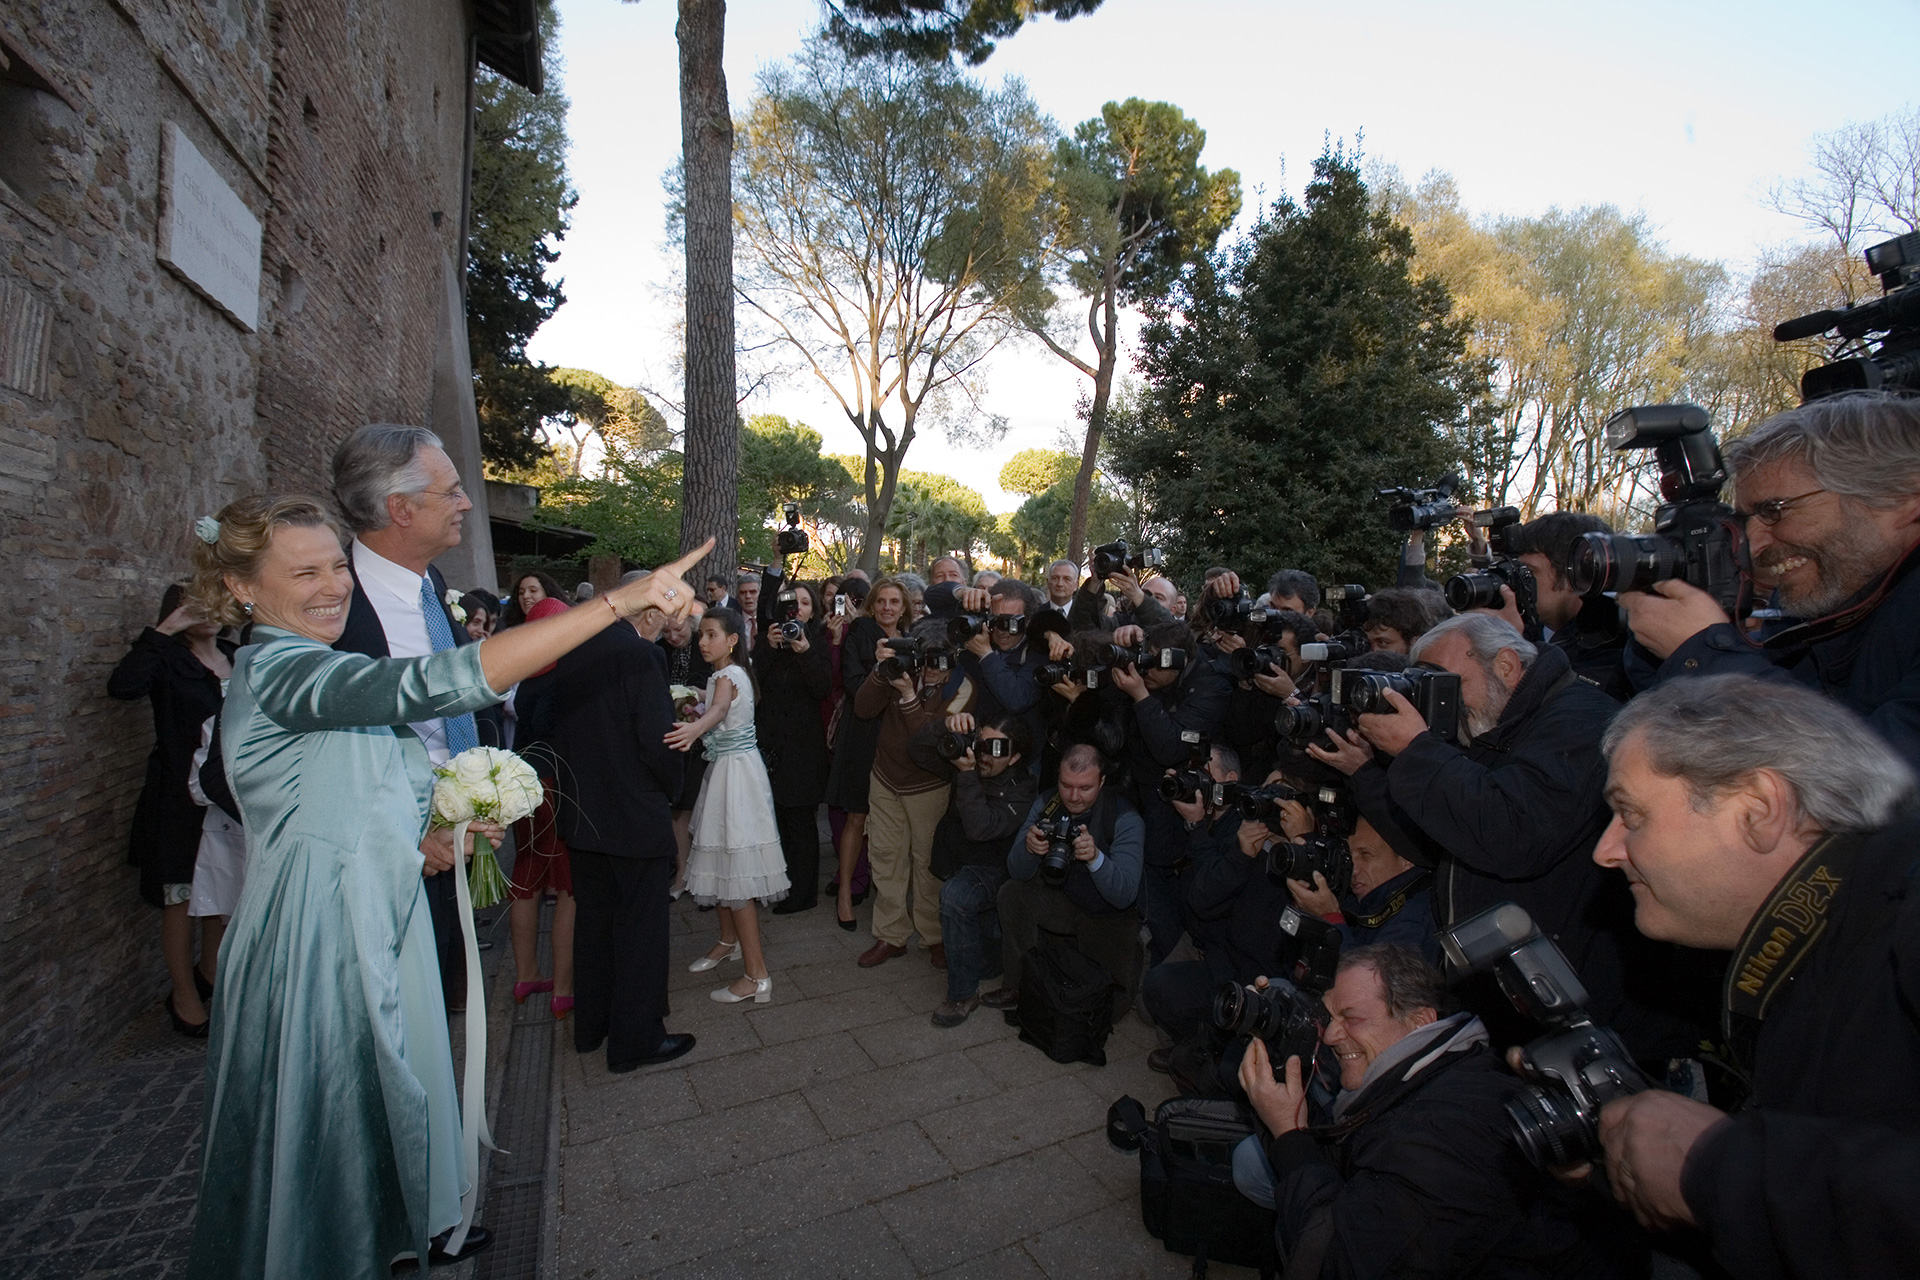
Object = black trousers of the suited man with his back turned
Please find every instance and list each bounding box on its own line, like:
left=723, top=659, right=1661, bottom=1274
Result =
left=572, top=848, right=674, bottom=1067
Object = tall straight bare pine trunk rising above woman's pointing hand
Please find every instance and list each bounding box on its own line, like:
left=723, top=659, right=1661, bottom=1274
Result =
left=674, top=0, right=739, bottom=585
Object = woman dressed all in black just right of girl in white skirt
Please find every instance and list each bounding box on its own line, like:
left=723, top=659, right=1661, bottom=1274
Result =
left=753, top=581, right=833, bottom=915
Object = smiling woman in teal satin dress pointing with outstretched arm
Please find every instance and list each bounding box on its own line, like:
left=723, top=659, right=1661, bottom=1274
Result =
left=188, top=497, right=710, bottom=1280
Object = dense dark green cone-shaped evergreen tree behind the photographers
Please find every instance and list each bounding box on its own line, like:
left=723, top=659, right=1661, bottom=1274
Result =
left=1112, top=150, right=1486, bottom=583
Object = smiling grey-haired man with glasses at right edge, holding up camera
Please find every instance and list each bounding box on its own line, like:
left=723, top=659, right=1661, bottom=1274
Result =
left=1619, top=391, right=1920, bottom=764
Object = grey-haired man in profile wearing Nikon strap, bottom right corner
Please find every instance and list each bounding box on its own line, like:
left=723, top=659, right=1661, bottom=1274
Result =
left=1594, top=676, right=1920, bottom=1278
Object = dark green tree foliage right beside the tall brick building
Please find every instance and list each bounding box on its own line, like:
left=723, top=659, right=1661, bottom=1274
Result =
left=467, top=4, right=578, bottom=466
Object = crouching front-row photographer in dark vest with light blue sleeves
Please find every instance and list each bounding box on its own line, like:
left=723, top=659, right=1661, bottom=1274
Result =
left=981, top=743, right=1144, bottom=1009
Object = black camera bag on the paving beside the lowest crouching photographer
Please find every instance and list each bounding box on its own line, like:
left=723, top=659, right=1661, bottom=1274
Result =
left=1106, top=1098, right=1281, bottom=1278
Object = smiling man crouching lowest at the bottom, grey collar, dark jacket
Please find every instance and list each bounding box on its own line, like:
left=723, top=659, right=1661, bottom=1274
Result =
left=1233, top=942, right=1613, bottom=1280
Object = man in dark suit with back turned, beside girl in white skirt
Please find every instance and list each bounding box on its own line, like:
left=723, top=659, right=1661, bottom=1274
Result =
left=553, top=574, right=693, bottom=1071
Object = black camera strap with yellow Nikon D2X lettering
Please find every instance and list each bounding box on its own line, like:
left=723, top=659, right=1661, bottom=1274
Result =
left=1722, top=835, right=1866, bottom=1067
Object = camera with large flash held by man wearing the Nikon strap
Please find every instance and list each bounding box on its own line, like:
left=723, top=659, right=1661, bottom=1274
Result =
left=1440, top=902, right=1651, bottom=1169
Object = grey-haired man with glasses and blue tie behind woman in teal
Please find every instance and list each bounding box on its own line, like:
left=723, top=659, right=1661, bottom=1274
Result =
left=334, top=422, right=478, bottom=1013
